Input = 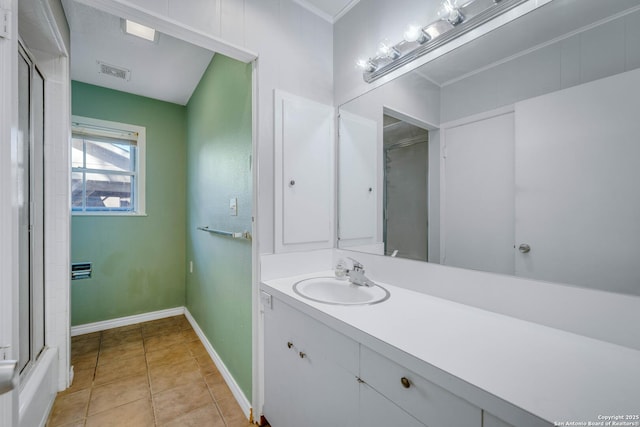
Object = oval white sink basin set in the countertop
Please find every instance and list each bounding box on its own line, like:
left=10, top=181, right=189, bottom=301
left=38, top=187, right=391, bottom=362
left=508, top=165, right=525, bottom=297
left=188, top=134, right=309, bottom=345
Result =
left=293, top=277, right=390, bottom=305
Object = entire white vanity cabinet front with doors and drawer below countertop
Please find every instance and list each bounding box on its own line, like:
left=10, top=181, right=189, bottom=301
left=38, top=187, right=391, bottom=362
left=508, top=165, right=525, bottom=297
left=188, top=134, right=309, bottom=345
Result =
left=264, top=298, right=482, bottom=427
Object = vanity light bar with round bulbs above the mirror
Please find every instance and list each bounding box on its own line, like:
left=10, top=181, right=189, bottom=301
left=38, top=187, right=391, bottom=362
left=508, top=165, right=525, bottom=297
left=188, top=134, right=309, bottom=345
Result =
left=356, top=0, right=529, bottom=83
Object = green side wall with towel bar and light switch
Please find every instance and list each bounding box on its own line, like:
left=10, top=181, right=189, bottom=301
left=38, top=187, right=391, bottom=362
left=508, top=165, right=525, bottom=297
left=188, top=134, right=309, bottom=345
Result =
left=187, top=54, right=252, bottom=399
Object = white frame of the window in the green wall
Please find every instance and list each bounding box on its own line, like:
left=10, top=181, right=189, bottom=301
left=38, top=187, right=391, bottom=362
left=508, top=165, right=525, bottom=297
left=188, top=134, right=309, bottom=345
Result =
left=69, top=115, right=147, bottom=216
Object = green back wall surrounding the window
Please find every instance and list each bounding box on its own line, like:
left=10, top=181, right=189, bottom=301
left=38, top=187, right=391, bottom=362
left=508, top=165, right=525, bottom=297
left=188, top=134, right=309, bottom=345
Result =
left=71, top=81, right=186, bottom=325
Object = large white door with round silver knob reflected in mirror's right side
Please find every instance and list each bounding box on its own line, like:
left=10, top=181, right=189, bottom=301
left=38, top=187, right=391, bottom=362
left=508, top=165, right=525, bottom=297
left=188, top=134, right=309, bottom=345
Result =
left=515, top=70, right=640, bottom=292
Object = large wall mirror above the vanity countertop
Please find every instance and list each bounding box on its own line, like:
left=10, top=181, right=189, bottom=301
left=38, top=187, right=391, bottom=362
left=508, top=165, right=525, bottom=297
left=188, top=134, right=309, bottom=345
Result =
left=338, top=0, right=640, bottom=295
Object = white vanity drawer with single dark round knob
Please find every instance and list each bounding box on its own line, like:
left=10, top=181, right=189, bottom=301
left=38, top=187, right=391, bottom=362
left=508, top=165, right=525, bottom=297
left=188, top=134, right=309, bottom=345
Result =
left=360, top=346, right=482, bottom=427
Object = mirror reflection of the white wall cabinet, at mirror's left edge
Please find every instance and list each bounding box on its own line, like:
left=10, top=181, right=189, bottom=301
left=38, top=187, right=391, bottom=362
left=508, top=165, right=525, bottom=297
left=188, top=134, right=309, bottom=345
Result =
left=338, top=111, right=378, bottom=247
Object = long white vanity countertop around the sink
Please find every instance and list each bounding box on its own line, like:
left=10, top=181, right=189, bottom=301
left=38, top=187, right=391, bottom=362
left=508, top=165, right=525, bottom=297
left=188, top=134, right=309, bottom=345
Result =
left=263, top=270, right=640, bottom=426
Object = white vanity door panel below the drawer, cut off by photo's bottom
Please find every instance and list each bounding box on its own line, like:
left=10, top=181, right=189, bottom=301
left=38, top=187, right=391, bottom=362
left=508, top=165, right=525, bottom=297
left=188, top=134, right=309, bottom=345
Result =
left=359, top=383, right=424, bottom=427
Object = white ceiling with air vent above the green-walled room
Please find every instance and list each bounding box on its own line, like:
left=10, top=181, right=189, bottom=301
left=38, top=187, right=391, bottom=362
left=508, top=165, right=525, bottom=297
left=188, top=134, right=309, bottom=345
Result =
left=62, top=0, right=214, bottom=105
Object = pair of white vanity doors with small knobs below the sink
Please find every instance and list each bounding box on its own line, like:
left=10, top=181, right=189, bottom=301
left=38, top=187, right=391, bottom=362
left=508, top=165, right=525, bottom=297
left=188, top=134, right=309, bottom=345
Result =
left=264, top=299, right=358, bottom=427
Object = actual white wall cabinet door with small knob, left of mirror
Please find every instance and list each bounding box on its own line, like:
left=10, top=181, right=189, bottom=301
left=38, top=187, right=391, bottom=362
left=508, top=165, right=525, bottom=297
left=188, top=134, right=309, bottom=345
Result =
left=275, top=92, right=335, bottom=252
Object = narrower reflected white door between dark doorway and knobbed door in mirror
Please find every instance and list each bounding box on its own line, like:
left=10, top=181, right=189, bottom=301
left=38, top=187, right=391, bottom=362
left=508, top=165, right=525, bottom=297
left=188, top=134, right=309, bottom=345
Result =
left=441, top=113, right=514, bottom=274
